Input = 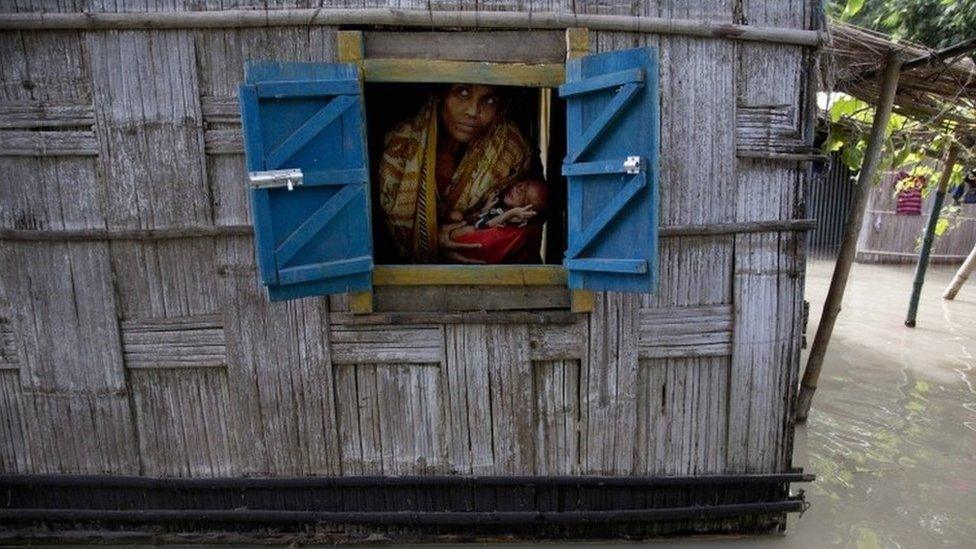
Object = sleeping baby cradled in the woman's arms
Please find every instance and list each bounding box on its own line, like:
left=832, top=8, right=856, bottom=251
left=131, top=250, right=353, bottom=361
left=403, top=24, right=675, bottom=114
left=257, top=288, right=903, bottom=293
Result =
left=448, top=179, right=549, bottom=240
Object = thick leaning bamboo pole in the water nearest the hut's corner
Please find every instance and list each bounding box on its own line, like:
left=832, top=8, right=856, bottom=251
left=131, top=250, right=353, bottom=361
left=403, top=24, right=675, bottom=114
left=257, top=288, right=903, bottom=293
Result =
left=795, top=51, right=902, bottom=422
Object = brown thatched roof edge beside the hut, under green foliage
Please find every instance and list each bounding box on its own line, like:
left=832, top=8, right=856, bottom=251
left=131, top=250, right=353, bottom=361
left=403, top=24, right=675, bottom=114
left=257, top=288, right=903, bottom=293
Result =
left=822, top=22, right=976, bottom=136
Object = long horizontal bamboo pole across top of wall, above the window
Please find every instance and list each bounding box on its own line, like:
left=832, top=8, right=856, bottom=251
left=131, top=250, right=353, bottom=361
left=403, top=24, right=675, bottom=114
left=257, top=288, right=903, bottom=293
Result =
left=0, top=8, right=825, bottom=47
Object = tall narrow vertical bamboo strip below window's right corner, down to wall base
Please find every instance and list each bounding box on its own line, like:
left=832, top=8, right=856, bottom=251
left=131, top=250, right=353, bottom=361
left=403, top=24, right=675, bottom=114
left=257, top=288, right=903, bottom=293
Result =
left=580, top=292, right=640, bottom=475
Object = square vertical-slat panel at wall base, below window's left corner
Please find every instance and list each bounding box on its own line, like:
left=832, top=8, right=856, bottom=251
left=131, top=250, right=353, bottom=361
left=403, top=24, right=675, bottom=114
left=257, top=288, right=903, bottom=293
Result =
left=335, top=364, right=447, bottom=476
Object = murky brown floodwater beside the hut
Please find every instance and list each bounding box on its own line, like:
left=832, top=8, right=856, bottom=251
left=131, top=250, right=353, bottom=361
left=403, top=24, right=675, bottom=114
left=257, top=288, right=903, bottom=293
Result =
left=778, top=260, right=976, bottom=548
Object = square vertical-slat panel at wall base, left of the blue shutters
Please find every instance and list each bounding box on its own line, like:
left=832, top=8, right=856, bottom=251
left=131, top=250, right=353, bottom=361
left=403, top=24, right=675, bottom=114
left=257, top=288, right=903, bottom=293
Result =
left=129, top=368, right=237, bottom=477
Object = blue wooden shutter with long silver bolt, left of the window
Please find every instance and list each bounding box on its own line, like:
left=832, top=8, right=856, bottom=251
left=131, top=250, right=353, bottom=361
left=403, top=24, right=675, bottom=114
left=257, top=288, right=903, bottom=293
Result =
left=240, top=62, right=373, bottom=301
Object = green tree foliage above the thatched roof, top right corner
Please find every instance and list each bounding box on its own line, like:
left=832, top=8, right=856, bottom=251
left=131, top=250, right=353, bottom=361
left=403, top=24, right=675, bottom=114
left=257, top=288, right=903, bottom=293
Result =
left=826, top=0, right=976, bottom=49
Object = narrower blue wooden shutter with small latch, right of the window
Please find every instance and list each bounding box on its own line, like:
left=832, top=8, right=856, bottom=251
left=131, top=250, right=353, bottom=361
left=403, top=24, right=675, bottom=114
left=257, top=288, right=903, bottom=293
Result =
left=559, top=48, right=660, bottom=292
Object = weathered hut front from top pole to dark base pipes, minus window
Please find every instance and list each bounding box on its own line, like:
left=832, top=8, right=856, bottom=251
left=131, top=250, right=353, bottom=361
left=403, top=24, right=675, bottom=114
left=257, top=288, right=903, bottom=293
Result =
left=0, top=0, right=821, bottom=535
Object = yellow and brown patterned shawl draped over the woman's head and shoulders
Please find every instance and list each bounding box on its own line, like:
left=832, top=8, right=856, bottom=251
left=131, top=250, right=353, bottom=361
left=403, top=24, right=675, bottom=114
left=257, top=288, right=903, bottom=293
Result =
left=379, top=99, right=531, bottom=263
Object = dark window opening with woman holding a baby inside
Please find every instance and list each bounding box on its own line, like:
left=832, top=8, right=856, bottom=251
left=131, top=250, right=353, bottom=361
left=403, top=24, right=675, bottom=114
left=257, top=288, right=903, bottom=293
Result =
left=364, top=82, right=566, bottom=265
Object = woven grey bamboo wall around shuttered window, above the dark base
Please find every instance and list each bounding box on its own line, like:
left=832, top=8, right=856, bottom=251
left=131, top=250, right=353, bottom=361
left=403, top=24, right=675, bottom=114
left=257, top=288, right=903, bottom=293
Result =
left=0, top=0, right=812, bottom=477
